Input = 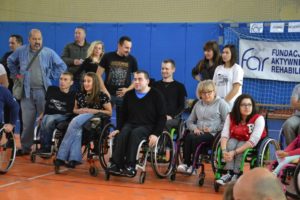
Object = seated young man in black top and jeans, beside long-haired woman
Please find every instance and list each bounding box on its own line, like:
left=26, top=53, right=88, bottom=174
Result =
left=37, top=72, right=75, bottom=153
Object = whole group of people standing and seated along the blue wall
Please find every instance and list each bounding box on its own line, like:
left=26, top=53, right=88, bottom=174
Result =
left=0, top=27, right=300, bottom=198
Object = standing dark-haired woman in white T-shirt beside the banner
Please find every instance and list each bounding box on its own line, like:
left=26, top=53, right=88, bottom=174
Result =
left=213, top=44, right=244, bottom=109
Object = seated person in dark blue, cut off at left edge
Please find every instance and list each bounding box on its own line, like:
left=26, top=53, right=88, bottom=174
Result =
left=0, top=85, right=19, bottom=133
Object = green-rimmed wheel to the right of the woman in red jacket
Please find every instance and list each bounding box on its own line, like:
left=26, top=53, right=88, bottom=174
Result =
left=257, top=137, right=280, bottom=167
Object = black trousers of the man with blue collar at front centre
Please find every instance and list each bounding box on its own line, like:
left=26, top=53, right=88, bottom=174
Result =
left=111, top=124, right=151, bottom=168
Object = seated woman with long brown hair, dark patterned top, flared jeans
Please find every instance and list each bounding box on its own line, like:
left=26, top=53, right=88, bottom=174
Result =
left=54, top=72, right=112, bottom=168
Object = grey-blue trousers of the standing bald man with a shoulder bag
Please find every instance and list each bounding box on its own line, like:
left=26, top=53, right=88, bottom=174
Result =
left=21, top=88, right=45, bottom=152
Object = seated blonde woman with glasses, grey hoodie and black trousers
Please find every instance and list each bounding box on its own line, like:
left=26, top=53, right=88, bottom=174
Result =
left=177, top=80, right=229, bottom=173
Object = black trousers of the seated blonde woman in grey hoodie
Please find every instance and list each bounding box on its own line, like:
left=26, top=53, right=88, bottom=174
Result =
left=183, top=132, right=214, bottom=166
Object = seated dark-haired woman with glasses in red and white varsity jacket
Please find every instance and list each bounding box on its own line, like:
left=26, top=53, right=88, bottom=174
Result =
left=217, top=94, right=267, bottom=185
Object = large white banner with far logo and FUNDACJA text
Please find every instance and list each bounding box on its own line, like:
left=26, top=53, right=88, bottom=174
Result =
left=239, top=39, right=300, bottom=82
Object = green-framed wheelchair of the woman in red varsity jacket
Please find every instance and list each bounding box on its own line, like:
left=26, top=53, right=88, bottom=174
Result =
left=211, top=136, right=280, bottom=192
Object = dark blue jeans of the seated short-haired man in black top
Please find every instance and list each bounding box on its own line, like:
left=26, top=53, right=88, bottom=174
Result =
left=40, top=114, right=68, bottom=149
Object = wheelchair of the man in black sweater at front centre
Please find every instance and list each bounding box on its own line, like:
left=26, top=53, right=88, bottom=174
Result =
left=99, top=124, right=174, bottom=184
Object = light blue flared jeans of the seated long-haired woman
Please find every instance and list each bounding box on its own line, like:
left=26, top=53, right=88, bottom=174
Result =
left=57, top=113, right=94, bottom=163
